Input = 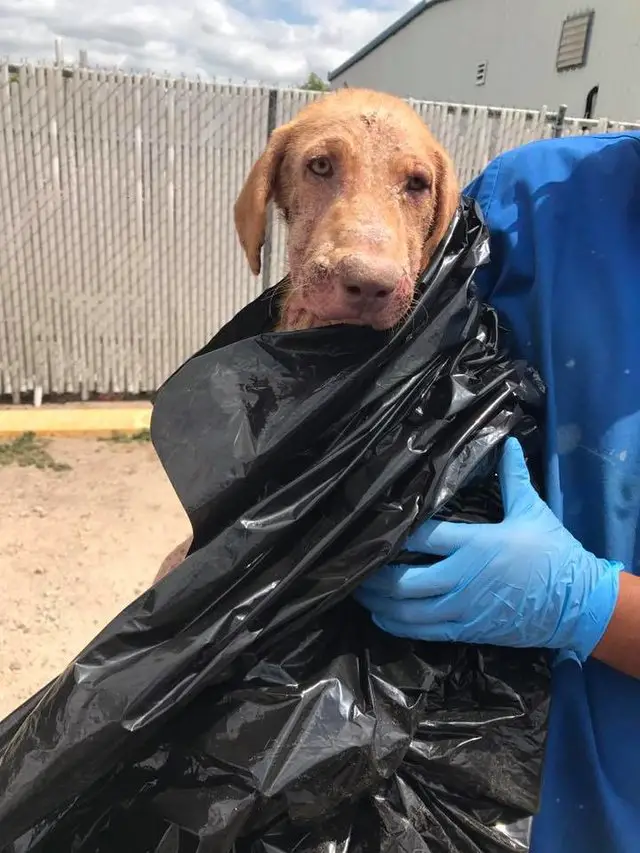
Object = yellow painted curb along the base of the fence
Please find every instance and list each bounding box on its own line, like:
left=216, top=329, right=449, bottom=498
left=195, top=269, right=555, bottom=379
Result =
left=0, top=406, right=151, bottom=437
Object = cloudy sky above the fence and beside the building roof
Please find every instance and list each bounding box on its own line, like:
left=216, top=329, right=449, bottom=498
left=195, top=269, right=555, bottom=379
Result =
left=0, top=0, right=416, bottom=85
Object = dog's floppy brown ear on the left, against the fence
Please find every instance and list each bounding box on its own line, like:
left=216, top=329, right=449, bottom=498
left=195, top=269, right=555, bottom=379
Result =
left=233, top=125, right=291, bottom=275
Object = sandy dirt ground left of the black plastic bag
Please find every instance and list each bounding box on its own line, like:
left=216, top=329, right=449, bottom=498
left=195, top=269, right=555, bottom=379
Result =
left=0, top=438, right=190, bottom=719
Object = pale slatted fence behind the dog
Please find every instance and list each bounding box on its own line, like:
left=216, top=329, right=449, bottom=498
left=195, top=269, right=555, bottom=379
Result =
left=0, top=65, right=631, bottom=403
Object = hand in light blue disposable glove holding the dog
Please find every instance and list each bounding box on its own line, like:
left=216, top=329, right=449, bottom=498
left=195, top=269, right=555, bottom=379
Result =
left=355, top=438, right=622, bottom=661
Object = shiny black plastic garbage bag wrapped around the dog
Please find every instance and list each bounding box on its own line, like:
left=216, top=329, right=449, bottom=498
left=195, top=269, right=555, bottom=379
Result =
left=0, top=196, right=549, bottom=853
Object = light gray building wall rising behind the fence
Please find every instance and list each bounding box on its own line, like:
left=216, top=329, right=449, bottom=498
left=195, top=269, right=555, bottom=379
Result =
left=331, top=0, right=640, bottom=121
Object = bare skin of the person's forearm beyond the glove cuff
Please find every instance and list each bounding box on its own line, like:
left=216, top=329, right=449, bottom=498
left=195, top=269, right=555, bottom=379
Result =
left=593, top=572, right=640, bottom=678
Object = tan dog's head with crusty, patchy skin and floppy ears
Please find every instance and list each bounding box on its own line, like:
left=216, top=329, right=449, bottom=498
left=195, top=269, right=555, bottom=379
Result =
left=235, top=89, right=459, bottom=329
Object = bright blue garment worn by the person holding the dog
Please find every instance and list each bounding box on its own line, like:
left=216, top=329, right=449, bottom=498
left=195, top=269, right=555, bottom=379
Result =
left=467, top=133, right=640, bottom=853
